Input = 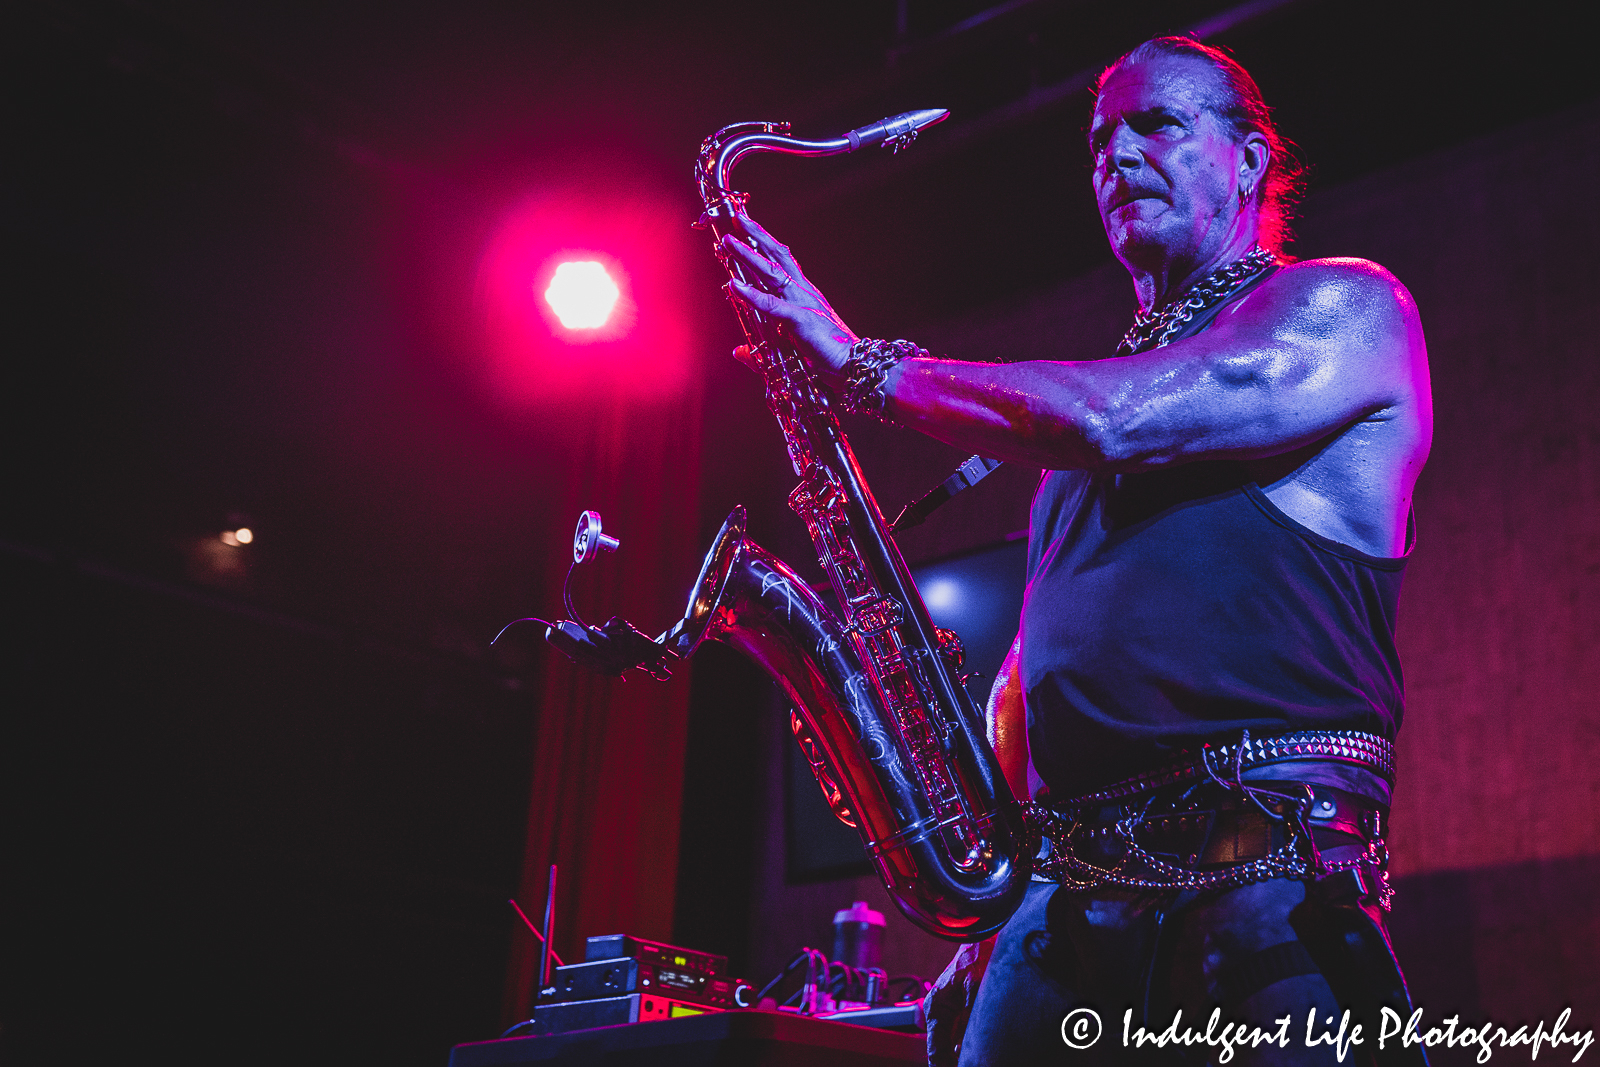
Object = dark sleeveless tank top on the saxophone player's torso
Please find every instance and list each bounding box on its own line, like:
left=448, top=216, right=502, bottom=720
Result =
left=1021, top=279, right=1410, bottom=798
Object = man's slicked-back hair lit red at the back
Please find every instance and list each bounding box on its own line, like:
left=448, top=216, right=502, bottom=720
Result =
left=1094, top=37, right=1306, bottom=254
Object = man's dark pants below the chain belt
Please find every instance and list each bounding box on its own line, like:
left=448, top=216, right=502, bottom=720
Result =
left=960, top=878, right=1421, bottom=1067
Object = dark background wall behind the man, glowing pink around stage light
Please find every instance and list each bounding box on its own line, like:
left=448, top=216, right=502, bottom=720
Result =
left=0, top=0, right=1600, bottom=1064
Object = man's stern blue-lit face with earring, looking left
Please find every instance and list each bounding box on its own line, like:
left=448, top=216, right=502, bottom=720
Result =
left=1090, top=56, right=1264, bottom=270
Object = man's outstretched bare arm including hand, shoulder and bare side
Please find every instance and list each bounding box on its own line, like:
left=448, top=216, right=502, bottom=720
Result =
left=725, top=212, right=1432, bottom=555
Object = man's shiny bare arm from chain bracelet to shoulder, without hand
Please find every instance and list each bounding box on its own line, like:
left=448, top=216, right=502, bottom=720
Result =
left=888, top=259, right=1426, bottom=472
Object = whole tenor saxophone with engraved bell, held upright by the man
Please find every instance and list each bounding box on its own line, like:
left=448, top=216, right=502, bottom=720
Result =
left=675, top=110, right=1037, bottom=941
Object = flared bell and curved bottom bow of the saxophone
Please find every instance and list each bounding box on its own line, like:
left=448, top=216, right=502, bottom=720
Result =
left=659, top=507, right=1038, bottom=941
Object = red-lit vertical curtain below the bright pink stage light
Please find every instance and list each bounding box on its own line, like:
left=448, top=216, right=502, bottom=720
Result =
left=506, top=388, right=704, bottom=1022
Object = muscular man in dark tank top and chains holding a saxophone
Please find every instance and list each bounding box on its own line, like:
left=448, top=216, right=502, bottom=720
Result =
left=725, top=38, right=1432, bottom=1064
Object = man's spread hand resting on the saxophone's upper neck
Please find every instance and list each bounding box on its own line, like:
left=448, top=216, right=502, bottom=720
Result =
left=722, top=214, right=858, bottom=387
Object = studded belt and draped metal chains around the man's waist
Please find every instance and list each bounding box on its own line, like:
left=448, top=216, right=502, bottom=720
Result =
left=1024, top=729, right=1394, bottom=910
